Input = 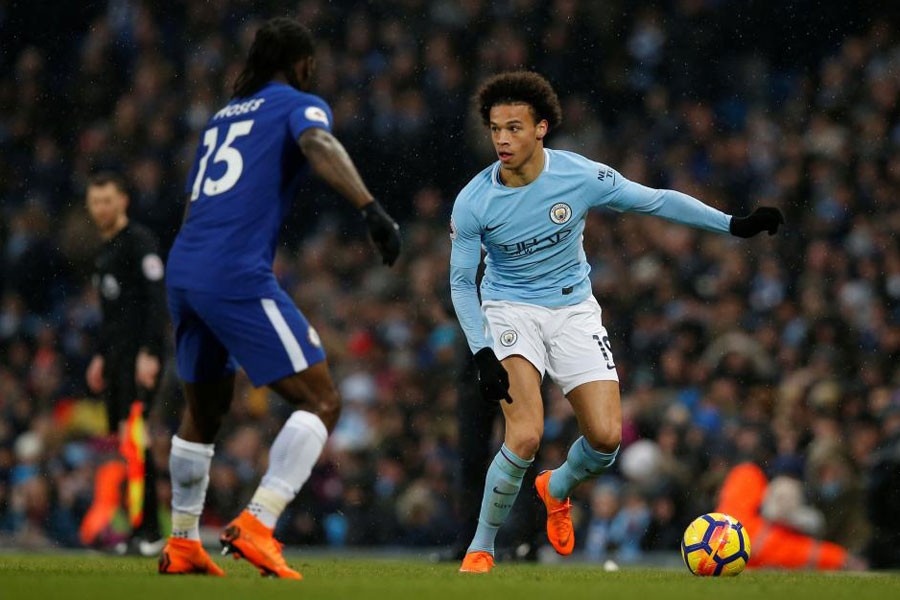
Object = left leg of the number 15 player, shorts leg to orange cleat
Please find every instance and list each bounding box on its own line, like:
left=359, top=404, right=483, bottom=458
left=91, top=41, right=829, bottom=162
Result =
left=159, top=289, right=235, bottom=576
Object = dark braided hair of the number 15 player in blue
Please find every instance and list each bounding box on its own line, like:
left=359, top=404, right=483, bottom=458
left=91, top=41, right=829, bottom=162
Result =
left=234, top=17, right=315, bottom=98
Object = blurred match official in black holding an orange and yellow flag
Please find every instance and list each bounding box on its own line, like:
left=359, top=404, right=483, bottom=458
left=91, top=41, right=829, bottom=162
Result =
left=86, top=172, right=167, bottom=556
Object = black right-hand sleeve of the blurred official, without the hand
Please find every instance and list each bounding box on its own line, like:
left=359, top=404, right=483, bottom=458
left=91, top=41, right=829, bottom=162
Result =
left=134, top=234, right=167, bottom=357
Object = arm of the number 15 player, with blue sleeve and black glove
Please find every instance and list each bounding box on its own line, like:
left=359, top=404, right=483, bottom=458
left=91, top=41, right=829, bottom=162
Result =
left=290, top=101, right=400, bottom=266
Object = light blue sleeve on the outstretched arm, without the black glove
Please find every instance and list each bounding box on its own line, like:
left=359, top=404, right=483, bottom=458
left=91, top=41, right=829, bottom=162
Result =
left=588, top=163, right=731, bottom=233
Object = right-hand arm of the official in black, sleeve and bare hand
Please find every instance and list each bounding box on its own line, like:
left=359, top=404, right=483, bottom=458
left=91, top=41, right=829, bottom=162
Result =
left=135, top=234, right=166, bottom=388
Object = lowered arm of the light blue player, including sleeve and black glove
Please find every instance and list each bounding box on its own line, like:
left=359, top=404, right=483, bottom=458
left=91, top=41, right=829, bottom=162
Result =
left=450, top=198, right=512, bottom=402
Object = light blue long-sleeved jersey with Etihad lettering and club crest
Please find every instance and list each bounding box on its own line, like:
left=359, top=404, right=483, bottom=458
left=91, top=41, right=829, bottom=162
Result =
left=450, top=149, right=731, bottom=352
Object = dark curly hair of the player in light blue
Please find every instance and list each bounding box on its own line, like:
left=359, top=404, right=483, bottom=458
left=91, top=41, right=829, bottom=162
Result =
left=474, top=71, right=562, bottom=129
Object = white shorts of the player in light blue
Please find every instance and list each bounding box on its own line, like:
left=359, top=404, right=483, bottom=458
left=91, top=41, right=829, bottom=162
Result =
left=481, top=296, right=619, bottom=394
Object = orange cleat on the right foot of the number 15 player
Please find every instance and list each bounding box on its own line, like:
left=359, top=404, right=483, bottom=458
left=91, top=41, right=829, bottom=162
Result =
left=219, top=510, right=303, bottom=579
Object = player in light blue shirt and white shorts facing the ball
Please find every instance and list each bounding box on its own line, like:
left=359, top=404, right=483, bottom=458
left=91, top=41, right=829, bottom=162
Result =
left=450, top=72, right=784, bottom=573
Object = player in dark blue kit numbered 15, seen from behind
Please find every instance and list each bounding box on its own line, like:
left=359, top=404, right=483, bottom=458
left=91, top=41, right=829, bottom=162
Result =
left=159, top=18, right=400, bottom=579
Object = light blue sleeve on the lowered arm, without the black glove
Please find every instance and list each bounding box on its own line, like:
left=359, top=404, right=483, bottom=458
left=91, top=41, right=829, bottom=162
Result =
left=450, top=198, right=488, bottom=354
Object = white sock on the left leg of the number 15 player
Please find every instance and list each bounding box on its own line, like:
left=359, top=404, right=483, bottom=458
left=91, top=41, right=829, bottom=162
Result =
left=169, top=435, right=213, bottom=540
